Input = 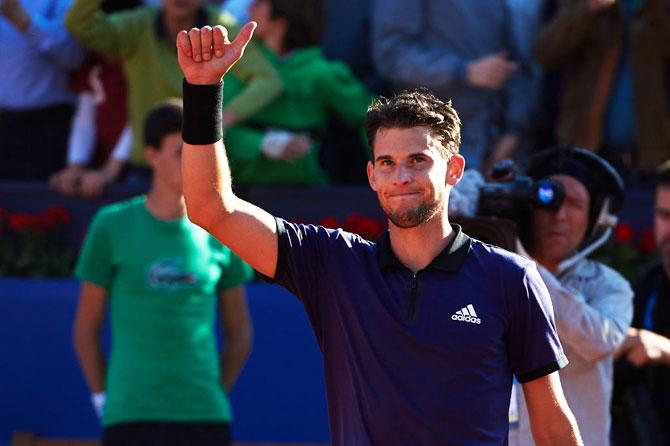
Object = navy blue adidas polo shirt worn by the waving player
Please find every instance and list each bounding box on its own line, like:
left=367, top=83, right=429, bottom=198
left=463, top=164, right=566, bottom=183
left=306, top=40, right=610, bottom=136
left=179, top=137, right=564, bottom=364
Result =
left=275, top=219, right=567, bottom=446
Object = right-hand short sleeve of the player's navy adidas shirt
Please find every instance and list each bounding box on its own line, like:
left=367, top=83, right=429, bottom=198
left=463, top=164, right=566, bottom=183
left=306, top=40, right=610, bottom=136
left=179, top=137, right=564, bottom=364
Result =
left=508, top=263, right=568, bottom=383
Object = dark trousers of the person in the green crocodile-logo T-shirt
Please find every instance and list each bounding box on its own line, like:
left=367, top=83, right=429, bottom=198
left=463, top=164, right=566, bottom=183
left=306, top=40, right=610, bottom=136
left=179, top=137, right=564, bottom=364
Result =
left=102, top=422, right=231, bottom=446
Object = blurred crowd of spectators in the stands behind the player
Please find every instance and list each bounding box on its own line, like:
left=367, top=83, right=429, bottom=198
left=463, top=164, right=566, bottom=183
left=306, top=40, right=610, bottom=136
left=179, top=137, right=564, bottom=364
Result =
left=0, top=0, right=670, bottom=196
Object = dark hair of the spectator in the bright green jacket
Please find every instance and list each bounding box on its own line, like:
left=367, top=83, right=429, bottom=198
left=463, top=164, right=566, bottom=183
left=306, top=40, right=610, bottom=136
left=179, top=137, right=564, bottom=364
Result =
left=268, top=0, right=326, bottom=51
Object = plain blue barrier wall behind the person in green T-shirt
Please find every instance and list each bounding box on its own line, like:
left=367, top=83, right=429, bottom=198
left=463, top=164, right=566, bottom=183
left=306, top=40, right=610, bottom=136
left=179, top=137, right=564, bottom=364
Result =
left=0, top=279, right=329, bottom=445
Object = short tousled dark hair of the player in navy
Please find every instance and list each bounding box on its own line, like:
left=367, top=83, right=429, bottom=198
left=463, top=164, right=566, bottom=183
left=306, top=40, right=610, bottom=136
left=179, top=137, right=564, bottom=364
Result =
left=365, top=88, right=461, bottom=158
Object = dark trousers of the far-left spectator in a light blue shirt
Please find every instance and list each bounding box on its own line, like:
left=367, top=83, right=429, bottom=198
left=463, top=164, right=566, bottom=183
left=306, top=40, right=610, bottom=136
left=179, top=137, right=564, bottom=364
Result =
left=0, top=104, right=74, bottom=180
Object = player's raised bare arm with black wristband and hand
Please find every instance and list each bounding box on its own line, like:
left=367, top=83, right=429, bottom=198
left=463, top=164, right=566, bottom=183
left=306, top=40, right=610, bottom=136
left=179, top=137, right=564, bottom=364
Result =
left=177, top=22, right=278, bottom=277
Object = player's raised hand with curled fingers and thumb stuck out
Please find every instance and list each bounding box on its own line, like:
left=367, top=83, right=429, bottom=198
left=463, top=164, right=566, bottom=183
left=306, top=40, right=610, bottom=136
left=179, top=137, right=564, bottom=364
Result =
left=177, top=22, right=256, bottom=85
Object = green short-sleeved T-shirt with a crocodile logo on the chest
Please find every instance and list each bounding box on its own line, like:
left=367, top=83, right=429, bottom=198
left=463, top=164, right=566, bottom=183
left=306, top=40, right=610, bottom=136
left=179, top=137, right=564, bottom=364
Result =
left=76, top=197, right=252, bottom=426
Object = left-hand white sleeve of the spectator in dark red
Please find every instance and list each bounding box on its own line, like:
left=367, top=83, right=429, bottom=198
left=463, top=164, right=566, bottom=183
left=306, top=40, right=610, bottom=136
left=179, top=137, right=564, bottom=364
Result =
left=67, top=92, right=96, bottom=164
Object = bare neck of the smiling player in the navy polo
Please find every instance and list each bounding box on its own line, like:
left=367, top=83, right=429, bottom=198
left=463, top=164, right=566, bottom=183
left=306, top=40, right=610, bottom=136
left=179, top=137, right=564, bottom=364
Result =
left=389, top=213, right=456, bottom=273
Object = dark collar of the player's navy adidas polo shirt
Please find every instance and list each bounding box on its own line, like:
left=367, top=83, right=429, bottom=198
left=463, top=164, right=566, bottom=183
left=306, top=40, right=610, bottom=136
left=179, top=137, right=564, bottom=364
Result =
left=377, top=224, right=472, bottom=272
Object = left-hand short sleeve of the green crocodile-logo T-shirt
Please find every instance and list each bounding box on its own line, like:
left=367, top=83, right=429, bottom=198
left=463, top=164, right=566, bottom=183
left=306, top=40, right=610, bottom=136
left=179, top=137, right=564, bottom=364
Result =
left=75, top=212, right=114, bottom=290
